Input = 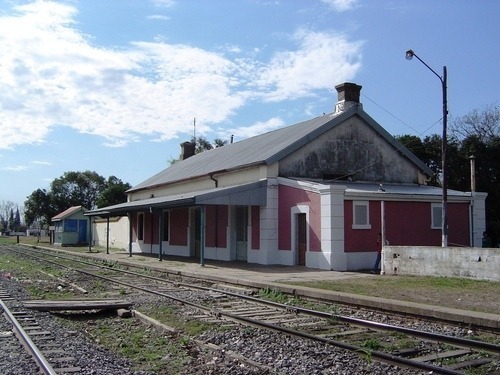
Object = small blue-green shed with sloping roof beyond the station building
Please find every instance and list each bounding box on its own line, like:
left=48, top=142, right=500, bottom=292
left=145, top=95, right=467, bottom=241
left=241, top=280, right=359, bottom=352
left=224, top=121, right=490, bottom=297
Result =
left=52, top=206, right=90, bottom=246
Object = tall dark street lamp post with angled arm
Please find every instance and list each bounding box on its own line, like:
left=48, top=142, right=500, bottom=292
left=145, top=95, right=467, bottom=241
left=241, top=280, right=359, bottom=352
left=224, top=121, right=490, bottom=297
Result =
left=406, top=49, right=448, bottom=247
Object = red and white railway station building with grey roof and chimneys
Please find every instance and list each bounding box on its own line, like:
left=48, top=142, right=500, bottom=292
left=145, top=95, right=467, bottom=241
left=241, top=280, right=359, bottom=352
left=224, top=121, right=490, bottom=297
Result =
left=86, top=83, right=486, bottom=271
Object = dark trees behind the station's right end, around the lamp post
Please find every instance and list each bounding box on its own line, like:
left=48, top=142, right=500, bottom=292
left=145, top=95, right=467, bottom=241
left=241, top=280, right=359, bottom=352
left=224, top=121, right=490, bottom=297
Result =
left=396, top=105, right=500, bottom=245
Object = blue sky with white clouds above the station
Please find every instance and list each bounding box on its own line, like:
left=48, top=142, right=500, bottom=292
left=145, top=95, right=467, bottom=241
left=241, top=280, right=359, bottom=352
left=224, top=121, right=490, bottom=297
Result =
left=0, top=0, right=500, bottom=209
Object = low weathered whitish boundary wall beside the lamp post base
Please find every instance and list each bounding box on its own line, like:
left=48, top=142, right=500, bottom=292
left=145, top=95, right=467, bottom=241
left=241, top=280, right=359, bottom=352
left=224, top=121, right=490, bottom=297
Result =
left=382, top=246, right=500, bottom=281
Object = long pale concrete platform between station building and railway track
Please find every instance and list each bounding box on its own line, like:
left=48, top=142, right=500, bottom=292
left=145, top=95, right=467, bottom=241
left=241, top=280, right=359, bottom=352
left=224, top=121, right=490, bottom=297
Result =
left=42, top=248, right=500, bottom=330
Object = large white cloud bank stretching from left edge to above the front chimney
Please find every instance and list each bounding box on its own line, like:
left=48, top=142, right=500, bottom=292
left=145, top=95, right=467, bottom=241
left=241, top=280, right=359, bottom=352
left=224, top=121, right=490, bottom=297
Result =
left=0, top=1, right=361, bottom=149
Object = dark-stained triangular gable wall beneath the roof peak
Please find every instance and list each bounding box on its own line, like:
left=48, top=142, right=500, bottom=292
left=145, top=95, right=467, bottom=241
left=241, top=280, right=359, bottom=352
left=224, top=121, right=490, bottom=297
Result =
left=279, top=117, right=418, bottom=183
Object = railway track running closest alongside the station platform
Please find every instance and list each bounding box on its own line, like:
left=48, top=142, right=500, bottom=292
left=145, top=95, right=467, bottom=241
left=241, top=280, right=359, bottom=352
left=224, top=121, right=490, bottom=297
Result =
left=0, top=245, right=500, bottom=374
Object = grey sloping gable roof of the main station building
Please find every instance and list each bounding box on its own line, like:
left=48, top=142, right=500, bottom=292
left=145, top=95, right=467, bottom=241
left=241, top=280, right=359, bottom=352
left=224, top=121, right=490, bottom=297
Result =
left=128, top=105, right=432, bottom=193
